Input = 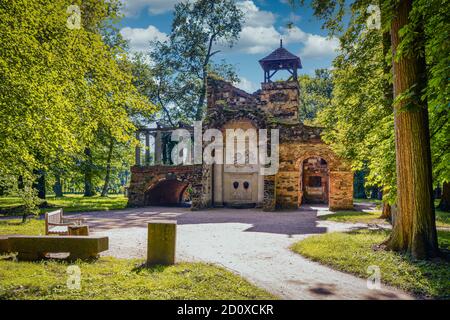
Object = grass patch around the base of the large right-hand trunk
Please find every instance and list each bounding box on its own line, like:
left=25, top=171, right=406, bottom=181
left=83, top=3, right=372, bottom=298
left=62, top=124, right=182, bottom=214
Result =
left=291, top=230, right=450, bottom=298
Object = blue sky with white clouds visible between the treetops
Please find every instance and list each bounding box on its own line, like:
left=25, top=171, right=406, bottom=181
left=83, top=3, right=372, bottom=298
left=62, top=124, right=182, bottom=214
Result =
left=120, top=0, right=338, bottom=92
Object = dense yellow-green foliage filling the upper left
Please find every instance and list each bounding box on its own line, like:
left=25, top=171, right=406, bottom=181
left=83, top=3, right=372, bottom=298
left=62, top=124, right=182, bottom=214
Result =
left=0, top=0, right=153, bottom=206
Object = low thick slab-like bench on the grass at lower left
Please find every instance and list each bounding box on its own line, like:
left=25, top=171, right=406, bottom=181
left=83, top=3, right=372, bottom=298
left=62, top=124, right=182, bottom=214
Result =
left=0, top=235, right=109, bottom=261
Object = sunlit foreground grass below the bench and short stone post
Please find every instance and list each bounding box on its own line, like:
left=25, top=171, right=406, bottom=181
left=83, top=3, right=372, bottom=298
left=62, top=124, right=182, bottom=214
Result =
left=0, top=258, right=276, bottom=300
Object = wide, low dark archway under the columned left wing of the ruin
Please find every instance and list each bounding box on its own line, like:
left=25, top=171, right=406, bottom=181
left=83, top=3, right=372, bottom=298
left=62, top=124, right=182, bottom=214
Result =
left=145, top=179, right=191, bottom=206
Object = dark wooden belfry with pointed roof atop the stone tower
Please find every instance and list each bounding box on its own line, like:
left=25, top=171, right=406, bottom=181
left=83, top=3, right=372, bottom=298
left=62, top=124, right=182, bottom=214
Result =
left=259, top=39, right=302, bottom=82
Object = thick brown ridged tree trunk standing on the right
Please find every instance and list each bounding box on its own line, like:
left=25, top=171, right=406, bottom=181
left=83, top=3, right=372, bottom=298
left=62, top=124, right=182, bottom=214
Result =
left=386, top=0, right=439, bottom=259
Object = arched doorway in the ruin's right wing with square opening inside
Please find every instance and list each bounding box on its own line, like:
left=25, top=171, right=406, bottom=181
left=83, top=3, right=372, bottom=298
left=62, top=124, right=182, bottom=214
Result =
left=300, top=157, right=330, bottom=204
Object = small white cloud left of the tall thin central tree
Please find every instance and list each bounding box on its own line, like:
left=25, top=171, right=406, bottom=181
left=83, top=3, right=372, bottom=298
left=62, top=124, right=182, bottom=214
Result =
left=120, top=25, right=167, bottom=52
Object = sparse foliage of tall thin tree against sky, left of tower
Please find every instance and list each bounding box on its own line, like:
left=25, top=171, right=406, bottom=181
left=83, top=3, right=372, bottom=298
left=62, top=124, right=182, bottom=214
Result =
left=150, top=0, right=243, bottom=125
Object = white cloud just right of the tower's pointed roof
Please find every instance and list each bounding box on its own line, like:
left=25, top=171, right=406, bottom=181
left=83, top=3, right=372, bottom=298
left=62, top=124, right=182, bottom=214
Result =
left=300, top=34, right=339, bottom=59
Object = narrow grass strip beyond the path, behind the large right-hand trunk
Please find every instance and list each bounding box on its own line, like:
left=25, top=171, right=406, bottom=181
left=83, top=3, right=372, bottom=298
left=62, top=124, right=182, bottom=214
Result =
left=319, top=210, right=450, bottom=228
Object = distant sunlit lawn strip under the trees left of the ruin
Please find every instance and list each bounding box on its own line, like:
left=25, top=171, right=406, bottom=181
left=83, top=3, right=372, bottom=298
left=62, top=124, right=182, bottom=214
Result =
left=0, top=194, right=128, bottom=215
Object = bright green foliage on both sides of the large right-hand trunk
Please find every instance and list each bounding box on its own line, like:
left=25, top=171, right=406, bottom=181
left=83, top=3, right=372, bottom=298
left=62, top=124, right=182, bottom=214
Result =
left=304, top=0, right=450, bottom=203
